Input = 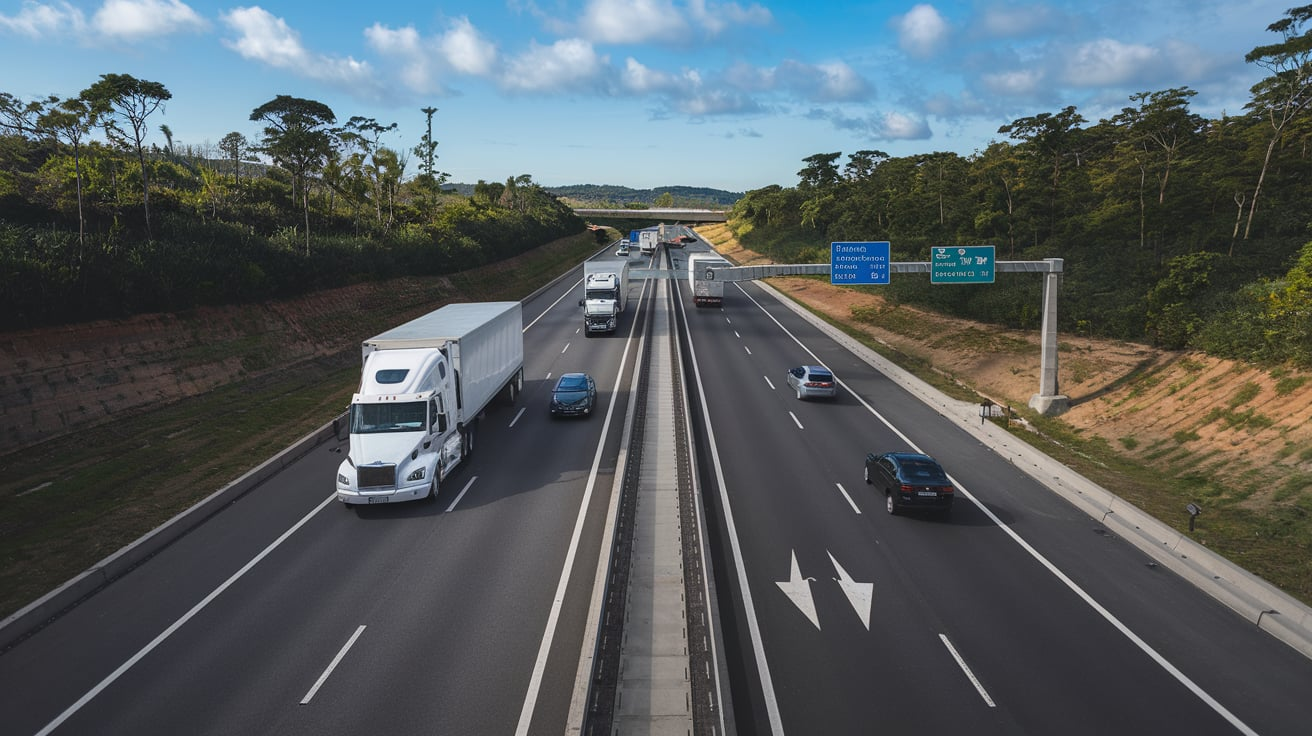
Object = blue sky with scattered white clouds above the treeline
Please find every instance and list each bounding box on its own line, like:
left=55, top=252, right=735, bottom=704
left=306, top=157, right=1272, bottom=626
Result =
left=0, top=0, right=1291, bottom=192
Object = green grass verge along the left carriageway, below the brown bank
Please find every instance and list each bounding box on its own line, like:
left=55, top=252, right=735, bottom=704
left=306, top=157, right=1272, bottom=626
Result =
left=0, top=234, right=597, bottom=617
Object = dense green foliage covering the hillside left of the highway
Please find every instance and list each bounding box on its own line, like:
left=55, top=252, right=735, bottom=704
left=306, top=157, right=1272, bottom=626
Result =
left=0, top=120, right=583, bottom=329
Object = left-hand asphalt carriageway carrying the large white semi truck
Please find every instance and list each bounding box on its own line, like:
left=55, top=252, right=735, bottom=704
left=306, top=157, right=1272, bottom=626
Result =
left=0, top=254, right=653, bottom=735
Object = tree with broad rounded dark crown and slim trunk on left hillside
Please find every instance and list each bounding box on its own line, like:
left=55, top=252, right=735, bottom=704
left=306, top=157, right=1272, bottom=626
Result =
left=251, top=94, right=337, bottom=255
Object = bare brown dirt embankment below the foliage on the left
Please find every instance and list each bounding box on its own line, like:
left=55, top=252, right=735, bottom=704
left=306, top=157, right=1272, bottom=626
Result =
left=0, top=281, right=459, bottom=455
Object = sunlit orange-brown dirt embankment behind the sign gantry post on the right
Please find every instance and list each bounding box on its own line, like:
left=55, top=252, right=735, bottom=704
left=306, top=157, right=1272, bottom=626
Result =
left=699, top=226, right=1312, bottom=509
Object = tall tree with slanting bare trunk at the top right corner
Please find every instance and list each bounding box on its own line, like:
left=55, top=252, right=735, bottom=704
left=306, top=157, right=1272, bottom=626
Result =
left=1244, top=5, right=1312, bottom=240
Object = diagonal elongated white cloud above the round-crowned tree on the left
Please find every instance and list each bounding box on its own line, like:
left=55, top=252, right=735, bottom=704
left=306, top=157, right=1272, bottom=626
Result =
left=222, top=8, right=377, bottom=91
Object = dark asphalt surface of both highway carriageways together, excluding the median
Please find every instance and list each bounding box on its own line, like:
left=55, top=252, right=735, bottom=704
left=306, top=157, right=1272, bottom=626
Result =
left=0, top=238, right=1312, bottom=735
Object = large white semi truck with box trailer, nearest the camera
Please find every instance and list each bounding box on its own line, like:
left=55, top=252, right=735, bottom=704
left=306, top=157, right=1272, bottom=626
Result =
left=337, top=302, right=523, bottom=504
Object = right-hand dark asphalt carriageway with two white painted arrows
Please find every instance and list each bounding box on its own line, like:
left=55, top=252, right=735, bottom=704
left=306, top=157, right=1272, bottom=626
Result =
left=670, top=242, right=1312, bottom=735
